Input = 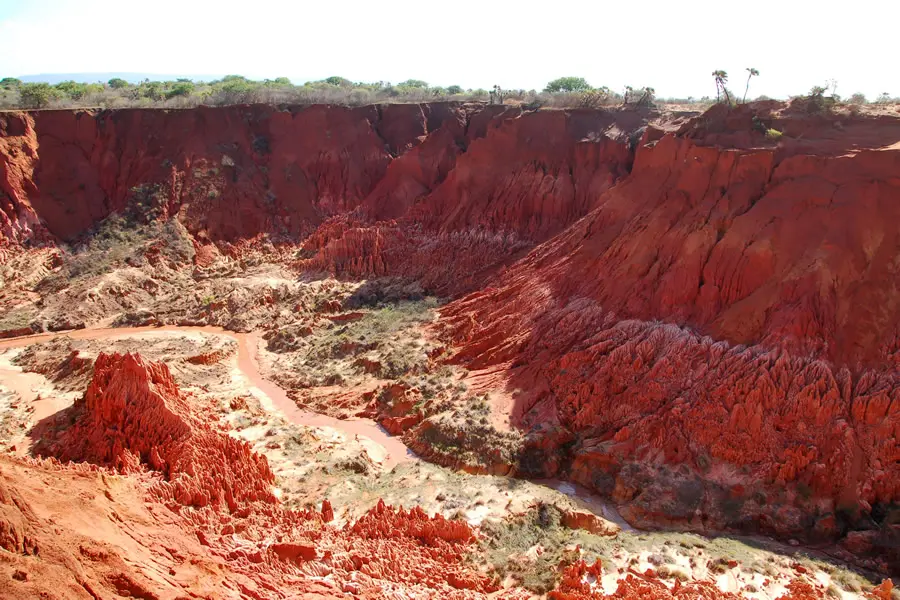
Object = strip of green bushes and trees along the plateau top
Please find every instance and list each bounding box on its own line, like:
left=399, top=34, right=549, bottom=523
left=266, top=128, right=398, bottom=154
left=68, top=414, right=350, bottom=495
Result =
left=0, top=73, right=900, bottom=109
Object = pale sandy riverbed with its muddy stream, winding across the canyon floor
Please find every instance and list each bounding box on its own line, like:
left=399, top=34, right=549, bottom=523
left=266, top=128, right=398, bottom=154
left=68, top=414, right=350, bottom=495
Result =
left=0, top=326, right=884, bottom=599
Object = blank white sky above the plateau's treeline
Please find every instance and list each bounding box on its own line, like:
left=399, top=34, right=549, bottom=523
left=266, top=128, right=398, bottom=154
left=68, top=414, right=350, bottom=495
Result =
left=0, top=0, right=900, bottom=99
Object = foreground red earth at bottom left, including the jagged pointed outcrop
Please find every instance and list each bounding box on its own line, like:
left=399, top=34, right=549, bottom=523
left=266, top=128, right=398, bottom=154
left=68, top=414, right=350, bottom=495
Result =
left=0, top=354, right=520, bottom=598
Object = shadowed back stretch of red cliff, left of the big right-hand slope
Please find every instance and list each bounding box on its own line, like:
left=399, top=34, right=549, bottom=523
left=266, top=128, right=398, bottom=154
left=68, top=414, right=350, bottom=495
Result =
left=0, top=103, right=643, bottom=293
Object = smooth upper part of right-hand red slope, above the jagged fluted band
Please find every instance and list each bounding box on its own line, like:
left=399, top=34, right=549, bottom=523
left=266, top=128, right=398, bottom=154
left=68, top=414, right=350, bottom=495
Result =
left=446, top=136, right=900, bottom=364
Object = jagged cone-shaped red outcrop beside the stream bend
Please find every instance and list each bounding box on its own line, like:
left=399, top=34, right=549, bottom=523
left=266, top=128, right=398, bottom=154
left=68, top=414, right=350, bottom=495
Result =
left=41, top=353, right=274, bottom=511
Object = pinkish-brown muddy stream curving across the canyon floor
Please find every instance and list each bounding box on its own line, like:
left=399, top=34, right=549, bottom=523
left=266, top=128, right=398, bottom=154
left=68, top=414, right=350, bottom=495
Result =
left=0, top=325, right=416, bottom=469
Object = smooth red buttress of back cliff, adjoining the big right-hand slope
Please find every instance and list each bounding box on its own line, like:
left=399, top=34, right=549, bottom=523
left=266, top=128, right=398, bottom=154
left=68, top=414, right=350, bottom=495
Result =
left=409, top=111, right=631, bottom=241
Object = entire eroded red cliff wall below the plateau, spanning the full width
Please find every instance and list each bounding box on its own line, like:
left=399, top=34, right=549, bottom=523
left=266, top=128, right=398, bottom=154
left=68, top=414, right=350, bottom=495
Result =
left=7, top=103, right=900, bottom=572
